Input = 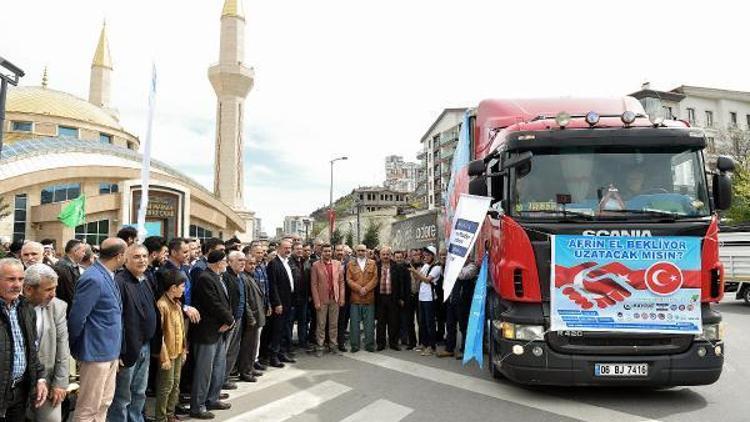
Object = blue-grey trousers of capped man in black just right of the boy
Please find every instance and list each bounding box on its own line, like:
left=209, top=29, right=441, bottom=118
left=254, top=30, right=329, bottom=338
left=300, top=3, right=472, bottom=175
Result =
left=190, top=336, right=227, bottom=412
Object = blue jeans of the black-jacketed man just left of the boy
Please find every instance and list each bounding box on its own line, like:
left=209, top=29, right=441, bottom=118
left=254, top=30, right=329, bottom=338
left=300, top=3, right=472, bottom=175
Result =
left=107, top=343, right=151, bottom=422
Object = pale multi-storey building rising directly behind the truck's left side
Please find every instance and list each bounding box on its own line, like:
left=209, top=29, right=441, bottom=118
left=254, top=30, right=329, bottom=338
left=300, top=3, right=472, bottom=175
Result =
left=416, top=108, right=466, bottom=209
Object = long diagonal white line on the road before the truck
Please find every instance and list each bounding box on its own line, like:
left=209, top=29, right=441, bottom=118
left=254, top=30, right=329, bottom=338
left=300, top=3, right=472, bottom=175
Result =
left=346, top=353, right=658, bottom=422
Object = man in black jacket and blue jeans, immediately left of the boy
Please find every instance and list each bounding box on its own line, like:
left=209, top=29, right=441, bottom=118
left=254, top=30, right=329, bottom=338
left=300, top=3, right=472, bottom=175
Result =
left=107, top=244, right=157, bottom=422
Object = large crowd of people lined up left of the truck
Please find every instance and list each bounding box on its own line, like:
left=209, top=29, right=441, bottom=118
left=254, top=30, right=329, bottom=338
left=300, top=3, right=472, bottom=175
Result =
left=0, top=227, right=478, bottom=422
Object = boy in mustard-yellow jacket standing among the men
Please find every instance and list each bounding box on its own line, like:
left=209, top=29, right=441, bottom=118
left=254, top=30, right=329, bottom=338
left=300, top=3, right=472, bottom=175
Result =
left=156, top=270, right=187, bottom=422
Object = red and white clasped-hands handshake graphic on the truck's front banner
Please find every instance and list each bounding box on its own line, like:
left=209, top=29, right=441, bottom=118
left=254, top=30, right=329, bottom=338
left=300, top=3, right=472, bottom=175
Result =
left=555, top=262, right=646, bottom=309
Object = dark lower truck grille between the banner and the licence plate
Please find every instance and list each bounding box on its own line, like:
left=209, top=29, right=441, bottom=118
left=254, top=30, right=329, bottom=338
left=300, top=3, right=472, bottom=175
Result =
left=547, top=332, right=693, bottom=355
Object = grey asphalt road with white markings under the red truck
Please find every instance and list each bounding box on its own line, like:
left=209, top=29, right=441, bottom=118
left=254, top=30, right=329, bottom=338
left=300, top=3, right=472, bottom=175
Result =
left=200, top=296, right=750, bottom=422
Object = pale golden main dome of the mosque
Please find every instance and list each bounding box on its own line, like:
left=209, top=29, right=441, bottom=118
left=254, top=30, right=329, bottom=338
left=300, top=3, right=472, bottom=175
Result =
left=6, top=86, right=123, bottom=130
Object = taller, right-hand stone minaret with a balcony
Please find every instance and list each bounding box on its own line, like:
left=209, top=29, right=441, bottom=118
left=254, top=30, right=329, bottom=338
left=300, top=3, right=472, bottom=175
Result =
left=208, top=0, right=255, bottom=211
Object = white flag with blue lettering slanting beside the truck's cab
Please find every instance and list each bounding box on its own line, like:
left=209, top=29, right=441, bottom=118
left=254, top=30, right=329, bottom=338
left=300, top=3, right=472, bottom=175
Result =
left=443, top=193, right=492, bottom=300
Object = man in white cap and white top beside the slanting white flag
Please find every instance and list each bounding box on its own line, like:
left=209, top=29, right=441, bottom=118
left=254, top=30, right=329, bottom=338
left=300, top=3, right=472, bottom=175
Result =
left=409, top=246, right=442, bottom=356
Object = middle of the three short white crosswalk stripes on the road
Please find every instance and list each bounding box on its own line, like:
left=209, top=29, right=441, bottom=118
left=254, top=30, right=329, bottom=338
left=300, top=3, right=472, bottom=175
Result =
left=227, top=381, right=351, bottom=422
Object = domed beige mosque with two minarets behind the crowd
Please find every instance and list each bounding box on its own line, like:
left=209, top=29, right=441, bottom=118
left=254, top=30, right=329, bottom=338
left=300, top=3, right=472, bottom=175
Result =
left=0, top=0, right=255, bottom=249
